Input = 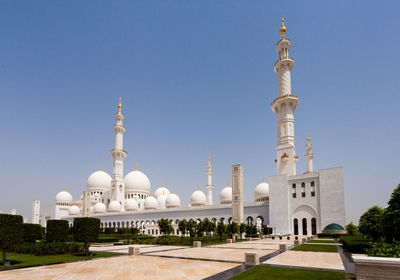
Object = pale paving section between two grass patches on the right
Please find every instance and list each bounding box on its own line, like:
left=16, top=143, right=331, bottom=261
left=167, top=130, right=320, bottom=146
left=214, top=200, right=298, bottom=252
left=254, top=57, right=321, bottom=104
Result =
left=263, top=251, right=344, bottom=271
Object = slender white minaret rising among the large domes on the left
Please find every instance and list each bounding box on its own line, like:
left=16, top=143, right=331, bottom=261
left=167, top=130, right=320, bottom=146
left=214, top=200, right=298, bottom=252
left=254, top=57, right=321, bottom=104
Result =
left=111, top=97, right=127, bottom=211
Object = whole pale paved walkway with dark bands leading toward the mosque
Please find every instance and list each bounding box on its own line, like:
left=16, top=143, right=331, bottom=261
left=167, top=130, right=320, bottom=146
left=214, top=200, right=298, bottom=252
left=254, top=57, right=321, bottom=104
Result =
left=0, top=236, right=350, bottom=280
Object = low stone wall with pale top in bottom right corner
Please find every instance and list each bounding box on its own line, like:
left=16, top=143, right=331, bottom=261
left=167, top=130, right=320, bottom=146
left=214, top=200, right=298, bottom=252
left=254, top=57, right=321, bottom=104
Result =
left=353, top=256, right=400, bottom=280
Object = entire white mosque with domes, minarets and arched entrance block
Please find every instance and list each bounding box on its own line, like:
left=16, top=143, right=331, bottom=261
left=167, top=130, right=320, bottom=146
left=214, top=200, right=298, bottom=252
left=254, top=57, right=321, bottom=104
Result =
left=36, top=18, right=345, bottom=235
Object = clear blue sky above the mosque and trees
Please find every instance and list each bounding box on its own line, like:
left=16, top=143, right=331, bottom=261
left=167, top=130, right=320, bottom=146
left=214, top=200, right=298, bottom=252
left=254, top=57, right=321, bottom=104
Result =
left=0, top=0, right=400, bottom=222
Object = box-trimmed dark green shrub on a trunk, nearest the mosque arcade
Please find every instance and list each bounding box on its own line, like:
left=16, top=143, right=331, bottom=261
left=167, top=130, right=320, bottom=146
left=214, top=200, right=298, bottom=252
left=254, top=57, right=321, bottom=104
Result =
left=74, top=217, right=100, bottom=255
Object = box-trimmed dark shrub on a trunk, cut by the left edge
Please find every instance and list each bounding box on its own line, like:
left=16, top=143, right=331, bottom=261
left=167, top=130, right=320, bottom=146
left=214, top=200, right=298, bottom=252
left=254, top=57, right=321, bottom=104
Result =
left=0, top=214, right=23, bottom=264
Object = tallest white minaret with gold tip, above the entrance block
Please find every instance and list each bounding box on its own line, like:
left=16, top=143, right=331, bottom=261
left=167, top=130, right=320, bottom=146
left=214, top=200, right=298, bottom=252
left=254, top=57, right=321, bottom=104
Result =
left=271, top=17, right=299, bottom=176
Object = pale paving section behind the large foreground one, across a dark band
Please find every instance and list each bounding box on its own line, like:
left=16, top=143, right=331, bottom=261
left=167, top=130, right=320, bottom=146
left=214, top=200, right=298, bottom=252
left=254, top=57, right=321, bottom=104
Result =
left=146, top=247, right=276, bottom=263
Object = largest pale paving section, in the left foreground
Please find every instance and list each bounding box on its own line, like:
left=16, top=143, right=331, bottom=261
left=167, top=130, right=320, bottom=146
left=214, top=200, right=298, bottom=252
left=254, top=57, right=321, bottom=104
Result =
left=0, top=256, right=237, bottom=280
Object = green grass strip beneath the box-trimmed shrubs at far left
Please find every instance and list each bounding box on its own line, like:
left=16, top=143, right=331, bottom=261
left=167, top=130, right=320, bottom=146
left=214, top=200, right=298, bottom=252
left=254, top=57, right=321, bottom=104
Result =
left=0, top=252, right=120, bottom=271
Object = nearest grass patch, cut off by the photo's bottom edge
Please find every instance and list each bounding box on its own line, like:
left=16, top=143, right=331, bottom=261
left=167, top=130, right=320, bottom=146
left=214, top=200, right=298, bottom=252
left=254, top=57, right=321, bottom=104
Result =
left=230, top=265, right=346, bottom=280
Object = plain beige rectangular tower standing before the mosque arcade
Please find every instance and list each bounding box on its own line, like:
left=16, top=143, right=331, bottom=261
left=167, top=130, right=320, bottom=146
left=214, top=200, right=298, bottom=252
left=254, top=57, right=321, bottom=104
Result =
left=232, top=164, right=244, bottom=224
